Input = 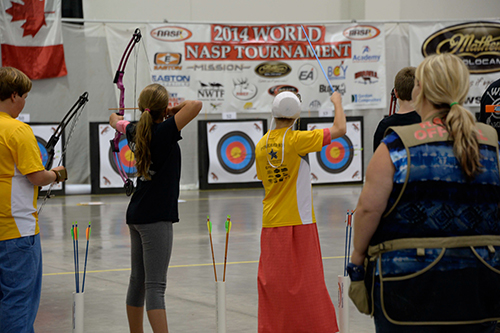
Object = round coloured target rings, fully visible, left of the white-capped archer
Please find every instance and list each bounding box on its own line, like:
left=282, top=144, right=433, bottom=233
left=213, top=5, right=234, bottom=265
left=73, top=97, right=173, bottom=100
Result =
left=217, top=131, right=255, bottom=174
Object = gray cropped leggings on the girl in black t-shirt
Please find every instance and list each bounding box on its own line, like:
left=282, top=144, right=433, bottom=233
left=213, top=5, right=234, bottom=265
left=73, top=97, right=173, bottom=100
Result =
left=127, top=222, right=173, bottom=311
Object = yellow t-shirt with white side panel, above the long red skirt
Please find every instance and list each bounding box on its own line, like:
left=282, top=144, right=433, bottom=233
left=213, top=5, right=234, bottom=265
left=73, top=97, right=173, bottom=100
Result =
left=255, top=128, right=331, bottom=228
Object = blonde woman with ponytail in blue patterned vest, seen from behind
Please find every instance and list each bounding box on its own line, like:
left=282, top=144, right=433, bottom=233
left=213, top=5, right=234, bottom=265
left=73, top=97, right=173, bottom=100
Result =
left=350, top=54, right=500, bottom=333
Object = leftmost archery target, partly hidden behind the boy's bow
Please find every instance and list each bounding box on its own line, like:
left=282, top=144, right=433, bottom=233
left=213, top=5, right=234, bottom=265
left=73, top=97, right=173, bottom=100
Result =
left=29, top=123, right=64, bottom=192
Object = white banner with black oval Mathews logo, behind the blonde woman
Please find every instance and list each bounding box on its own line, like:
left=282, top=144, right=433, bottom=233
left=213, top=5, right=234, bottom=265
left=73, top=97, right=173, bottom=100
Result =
left=410, top=21, right=500, bottom=106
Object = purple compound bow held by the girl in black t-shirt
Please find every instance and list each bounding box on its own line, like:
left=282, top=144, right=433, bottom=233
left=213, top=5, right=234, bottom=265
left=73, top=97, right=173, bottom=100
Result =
left=110, top=28, right=142, bottom=196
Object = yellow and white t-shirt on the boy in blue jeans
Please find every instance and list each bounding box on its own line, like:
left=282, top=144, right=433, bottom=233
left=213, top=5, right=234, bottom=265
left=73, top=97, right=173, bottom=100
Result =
left=0, top=112, right=44, bottom=241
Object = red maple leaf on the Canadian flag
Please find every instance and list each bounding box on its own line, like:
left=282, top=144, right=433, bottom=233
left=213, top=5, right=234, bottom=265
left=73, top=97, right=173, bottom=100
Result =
left=5, top=0, right=47, bottom=37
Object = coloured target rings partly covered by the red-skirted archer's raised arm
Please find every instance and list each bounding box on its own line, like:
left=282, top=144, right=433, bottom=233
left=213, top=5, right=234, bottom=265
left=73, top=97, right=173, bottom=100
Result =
left=316, top=135, right=354, bottom=173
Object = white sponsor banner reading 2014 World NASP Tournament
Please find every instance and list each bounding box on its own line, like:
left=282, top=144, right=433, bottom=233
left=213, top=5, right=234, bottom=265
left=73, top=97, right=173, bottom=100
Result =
left=144, top=23, right=386, bottom=113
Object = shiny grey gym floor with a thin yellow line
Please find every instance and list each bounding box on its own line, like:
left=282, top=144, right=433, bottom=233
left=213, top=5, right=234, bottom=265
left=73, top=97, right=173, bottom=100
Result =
left=35, top=185, right=375, bottom=333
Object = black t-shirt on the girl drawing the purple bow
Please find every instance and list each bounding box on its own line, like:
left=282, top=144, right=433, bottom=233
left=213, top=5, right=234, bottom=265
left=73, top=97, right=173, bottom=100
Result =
left=127, top=117, right=182, bottom=224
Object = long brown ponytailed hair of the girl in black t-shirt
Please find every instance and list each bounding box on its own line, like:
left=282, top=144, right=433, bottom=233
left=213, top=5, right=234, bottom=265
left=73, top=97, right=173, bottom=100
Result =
left=135, top=83, right=169, bottom=180
